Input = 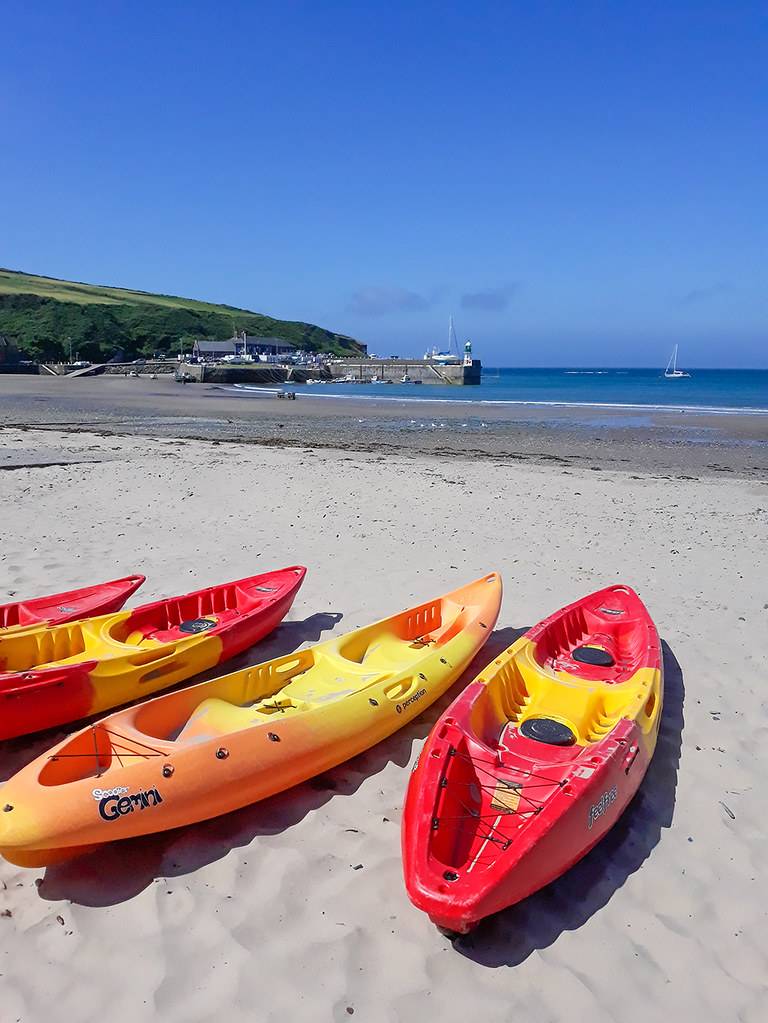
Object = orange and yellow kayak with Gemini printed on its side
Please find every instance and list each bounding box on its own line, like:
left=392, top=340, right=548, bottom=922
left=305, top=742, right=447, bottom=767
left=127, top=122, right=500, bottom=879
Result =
left=0, top=573, right=501, bottom=866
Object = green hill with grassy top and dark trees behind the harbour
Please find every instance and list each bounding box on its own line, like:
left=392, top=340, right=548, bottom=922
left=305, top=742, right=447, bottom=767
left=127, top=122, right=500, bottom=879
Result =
left=0, top=269, right=364, bottom=361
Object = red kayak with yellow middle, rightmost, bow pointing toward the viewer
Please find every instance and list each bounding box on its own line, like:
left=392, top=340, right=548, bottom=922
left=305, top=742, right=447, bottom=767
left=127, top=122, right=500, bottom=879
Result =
left=402, top=586, right=663, bottom=933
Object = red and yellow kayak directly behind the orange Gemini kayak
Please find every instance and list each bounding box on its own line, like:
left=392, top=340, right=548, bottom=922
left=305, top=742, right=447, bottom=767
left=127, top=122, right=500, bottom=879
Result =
left=0, top=565, right=307, bottom=739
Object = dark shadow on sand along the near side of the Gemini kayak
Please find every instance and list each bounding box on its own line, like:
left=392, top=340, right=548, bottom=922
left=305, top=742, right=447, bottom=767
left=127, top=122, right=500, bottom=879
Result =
left=38, top=616, right=526, bottom=906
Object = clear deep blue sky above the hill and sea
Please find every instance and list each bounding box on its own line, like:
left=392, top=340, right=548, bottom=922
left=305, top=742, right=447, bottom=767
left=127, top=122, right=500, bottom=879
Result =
left=0, top=0, right=768, bottom=366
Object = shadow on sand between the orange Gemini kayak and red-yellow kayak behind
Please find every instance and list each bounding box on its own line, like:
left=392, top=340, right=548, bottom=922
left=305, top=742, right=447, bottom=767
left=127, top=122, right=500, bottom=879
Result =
left=0, top=611, right=344, bottom=782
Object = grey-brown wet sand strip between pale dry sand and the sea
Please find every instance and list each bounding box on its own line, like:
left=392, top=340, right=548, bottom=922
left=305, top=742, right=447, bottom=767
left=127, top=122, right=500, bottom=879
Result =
left=0, top=376, right=768, bottom=480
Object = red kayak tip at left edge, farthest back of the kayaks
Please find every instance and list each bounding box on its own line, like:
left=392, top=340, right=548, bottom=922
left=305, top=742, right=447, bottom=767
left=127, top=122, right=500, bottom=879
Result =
left=0, top=575, right=144, bottom=635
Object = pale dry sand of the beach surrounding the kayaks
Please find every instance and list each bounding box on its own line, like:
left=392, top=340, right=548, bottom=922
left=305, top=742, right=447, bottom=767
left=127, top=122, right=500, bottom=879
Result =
left=0, top=429, right=768, bottom=1023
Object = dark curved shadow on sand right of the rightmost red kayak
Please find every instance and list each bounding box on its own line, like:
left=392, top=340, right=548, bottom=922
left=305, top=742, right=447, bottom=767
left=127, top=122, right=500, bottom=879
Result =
left=454, top=642, right=685, bottom=967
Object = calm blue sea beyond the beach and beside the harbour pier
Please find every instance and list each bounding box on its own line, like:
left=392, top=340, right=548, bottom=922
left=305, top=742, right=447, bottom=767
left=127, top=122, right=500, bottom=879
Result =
left=238, top=369, right=768, bottom=414
